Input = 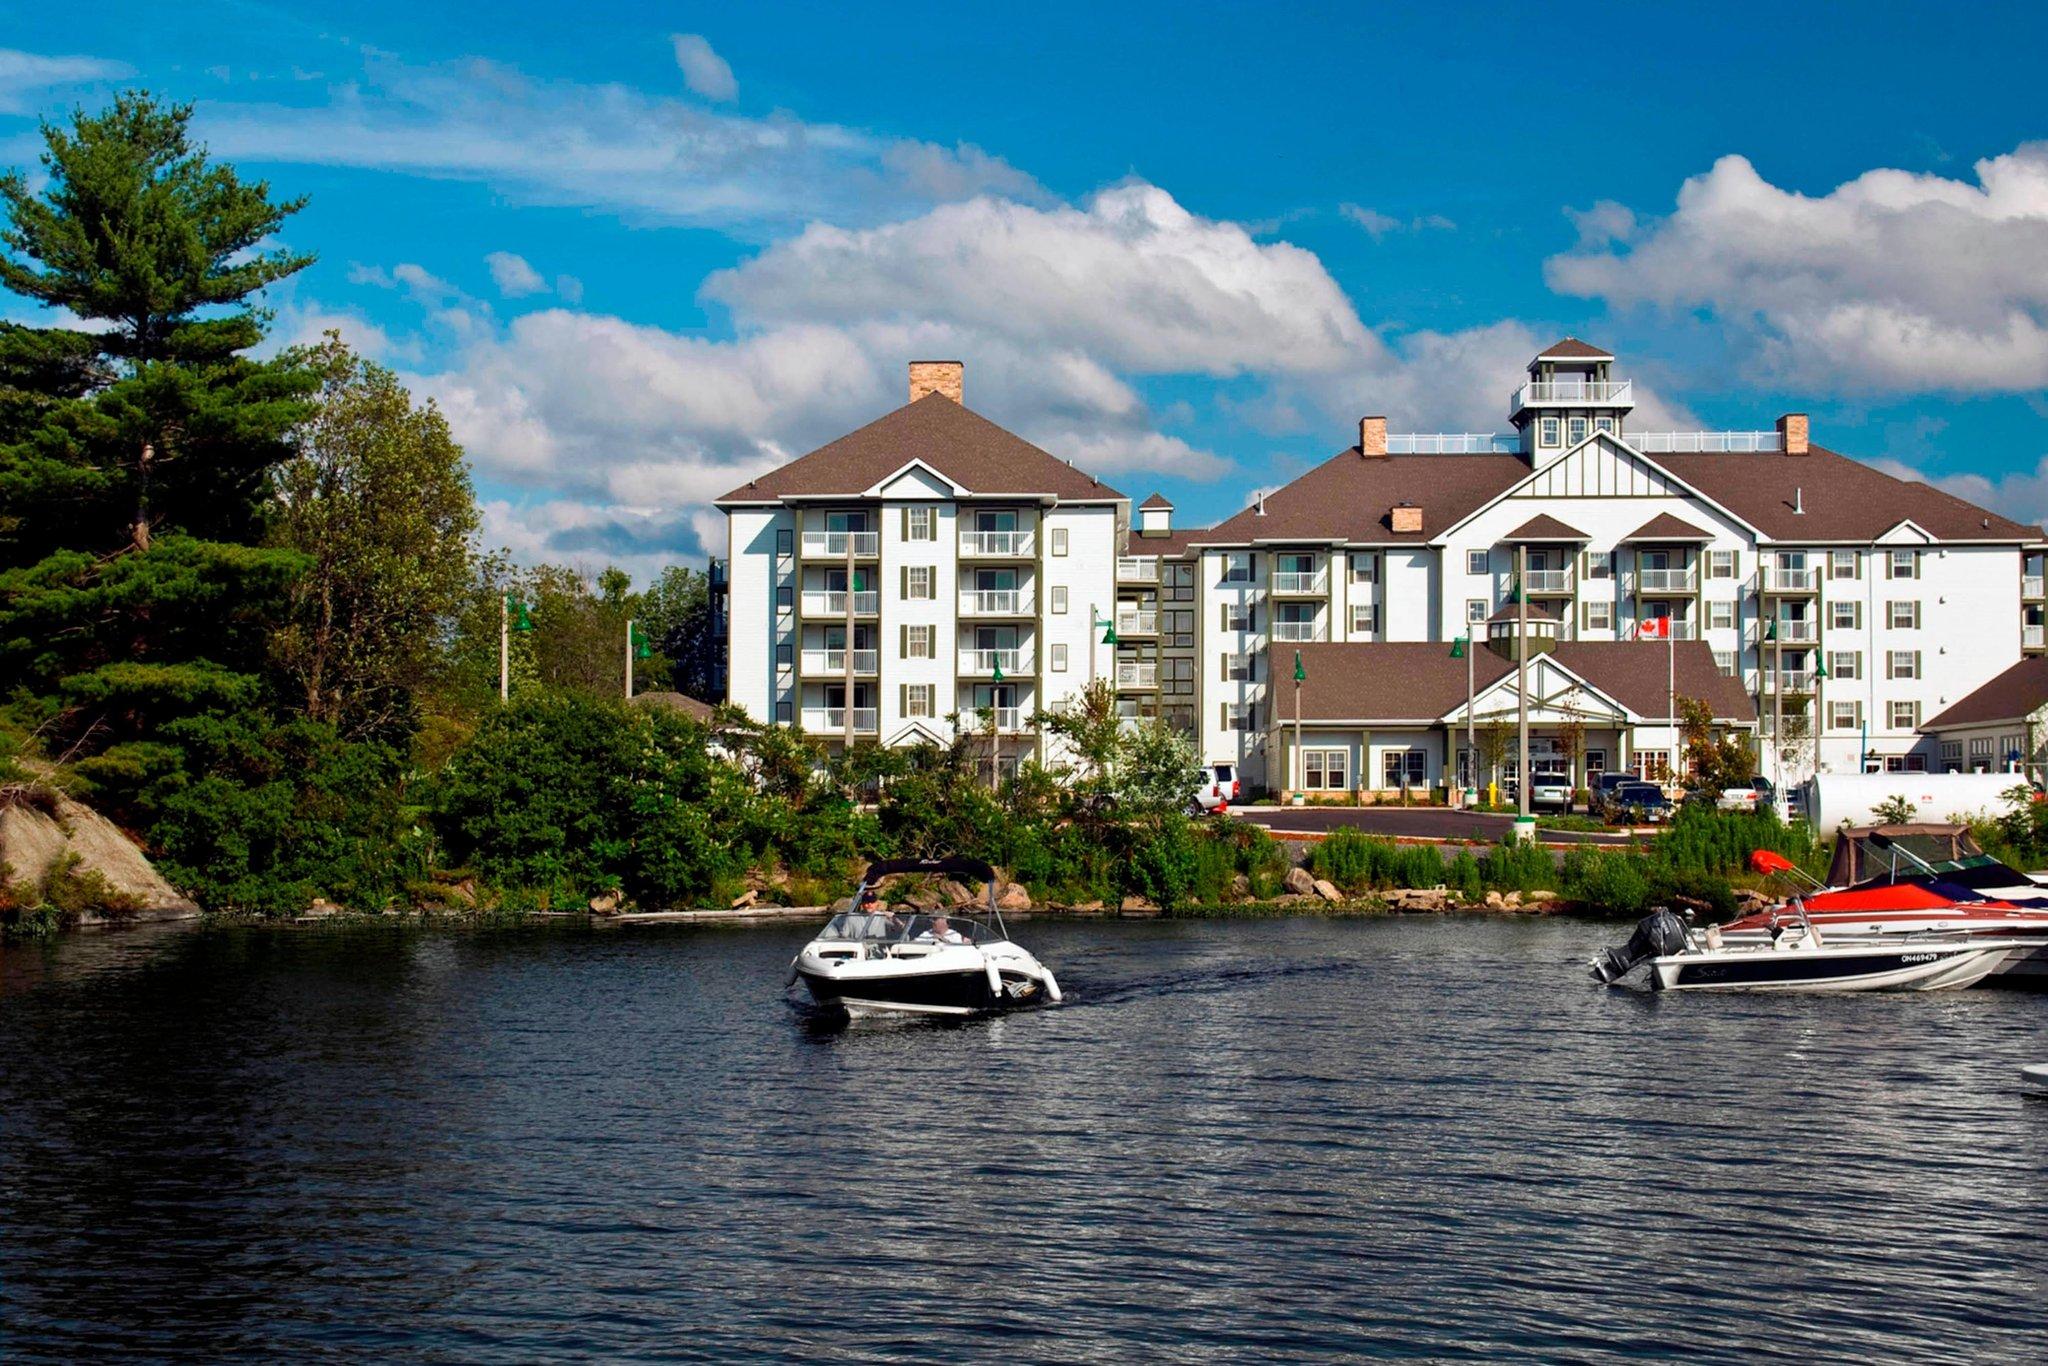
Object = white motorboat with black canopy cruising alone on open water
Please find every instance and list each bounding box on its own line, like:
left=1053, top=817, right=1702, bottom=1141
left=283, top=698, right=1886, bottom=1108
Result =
left=791, top=858, right=1061, bottom=1016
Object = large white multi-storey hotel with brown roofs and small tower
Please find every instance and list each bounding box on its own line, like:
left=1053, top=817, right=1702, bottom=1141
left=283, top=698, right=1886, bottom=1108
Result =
left=717, top=348, right=2048, bottom=795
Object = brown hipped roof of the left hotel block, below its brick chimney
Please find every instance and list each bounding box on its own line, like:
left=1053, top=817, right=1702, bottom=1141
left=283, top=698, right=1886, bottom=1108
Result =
left=719, top=393, right=1122, bottom=502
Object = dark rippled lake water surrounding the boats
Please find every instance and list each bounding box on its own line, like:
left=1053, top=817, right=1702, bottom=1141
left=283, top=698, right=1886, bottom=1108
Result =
left=0, top=917, right=2048, bottom=1362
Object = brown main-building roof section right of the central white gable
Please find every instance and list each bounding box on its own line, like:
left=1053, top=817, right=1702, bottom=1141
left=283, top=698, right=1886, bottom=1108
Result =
left=1647, top=446, right=2042, bottom=541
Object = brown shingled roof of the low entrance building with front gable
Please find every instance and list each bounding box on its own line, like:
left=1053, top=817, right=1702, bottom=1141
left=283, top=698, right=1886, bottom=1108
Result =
left=1288, top=641, right=1757, bottom=723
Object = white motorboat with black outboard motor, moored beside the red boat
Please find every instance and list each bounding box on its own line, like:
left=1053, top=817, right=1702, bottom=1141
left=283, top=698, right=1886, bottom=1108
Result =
left=1593, top=899, right=2036, bottom=991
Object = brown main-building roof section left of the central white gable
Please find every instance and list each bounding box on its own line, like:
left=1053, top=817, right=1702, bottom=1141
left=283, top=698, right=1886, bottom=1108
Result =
left=1196, top=446, right=1530, bottom=545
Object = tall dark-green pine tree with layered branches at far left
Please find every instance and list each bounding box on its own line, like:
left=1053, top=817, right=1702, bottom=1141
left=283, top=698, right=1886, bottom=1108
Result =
left=0, top=92, right=315, bottom=806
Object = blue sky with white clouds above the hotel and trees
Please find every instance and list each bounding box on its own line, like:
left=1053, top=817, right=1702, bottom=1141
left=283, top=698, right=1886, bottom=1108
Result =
left=0, top=0, right=2048, bottom=573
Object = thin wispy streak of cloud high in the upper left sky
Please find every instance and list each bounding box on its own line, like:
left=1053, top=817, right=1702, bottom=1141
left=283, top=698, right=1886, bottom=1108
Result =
left=197, top=44, right=1044, bottom=229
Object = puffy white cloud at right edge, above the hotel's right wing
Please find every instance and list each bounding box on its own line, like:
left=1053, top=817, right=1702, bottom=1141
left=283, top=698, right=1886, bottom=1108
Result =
left=1546, top=143, right=2048, bottom=393
